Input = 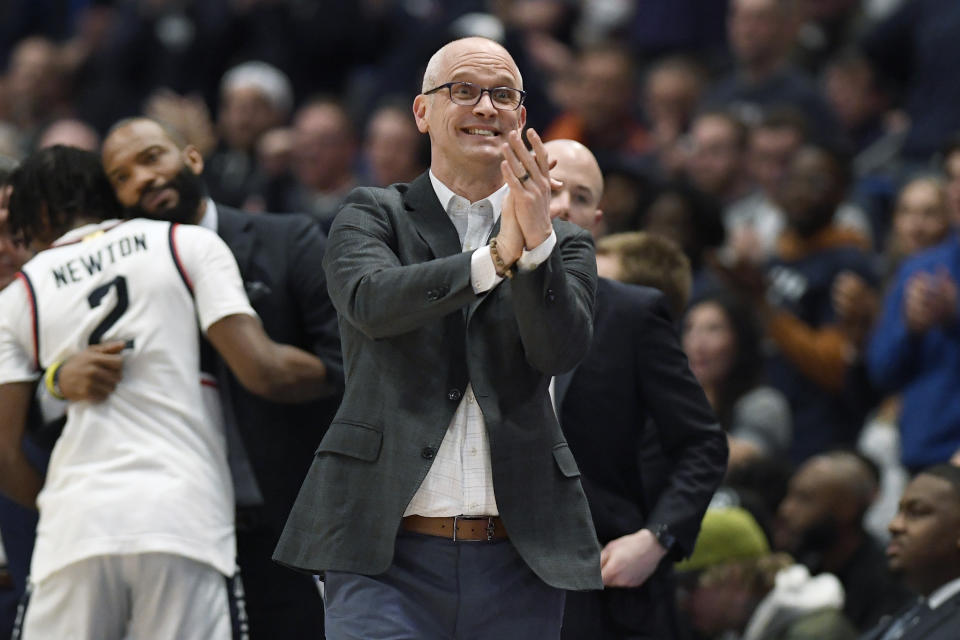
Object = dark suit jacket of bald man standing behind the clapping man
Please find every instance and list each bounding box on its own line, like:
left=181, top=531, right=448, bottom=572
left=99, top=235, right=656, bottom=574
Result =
left=555, top=278, right=727, bottom=637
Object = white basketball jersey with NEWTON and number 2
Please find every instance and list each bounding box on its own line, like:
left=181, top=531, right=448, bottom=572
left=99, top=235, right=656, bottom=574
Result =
left=0, top=220, right=255, bottom=581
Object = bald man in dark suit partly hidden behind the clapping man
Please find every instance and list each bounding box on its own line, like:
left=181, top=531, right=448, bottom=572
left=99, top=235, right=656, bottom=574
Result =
left=546, top=140, right=727, bottom=640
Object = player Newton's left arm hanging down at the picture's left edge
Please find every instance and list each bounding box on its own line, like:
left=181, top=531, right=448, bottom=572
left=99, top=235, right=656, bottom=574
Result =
left=0, top=382, right=43, bottom=509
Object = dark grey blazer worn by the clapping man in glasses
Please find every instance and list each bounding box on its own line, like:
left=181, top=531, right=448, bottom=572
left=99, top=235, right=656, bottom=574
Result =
left=274, top=174, right=600, bottom=589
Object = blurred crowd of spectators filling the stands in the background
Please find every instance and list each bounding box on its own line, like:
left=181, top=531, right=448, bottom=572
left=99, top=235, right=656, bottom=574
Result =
left=0, top=0, right=960, bottom=629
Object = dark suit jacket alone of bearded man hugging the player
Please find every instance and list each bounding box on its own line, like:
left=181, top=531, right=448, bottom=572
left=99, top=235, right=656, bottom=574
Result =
left=217, top=205, right=343, bottom=537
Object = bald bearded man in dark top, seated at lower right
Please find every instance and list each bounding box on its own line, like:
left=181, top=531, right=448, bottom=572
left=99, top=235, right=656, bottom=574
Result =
left=774, top=451, right=907, bottom=631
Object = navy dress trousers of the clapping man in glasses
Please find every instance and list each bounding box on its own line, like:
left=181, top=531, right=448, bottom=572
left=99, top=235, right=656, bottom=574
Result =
left=324, top=530, right=565, bottom=640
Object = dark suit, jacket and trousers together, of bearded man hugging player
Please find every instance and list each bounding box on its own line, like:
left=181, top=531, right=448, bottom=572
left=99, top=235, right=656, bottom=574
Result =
left=217, top=205, right=343, bottom=640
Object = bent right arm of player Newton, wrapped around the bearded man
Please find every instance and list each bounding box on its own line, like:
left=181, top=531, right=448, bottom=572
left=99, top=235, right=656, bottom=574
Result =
left=207, top=313, right=327, bottom=402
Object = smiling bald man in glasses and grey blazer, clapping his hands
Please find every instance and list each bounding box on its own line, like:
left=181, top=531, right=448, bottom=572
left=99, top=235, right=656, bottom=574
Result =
left=274, top=38, right=601, bottom=639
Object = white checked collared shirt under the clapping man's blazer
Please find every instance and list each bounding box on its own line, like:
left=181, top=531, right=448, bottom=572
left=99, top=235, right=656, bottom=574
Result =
left=403, top=171, right=557, bottom=517
